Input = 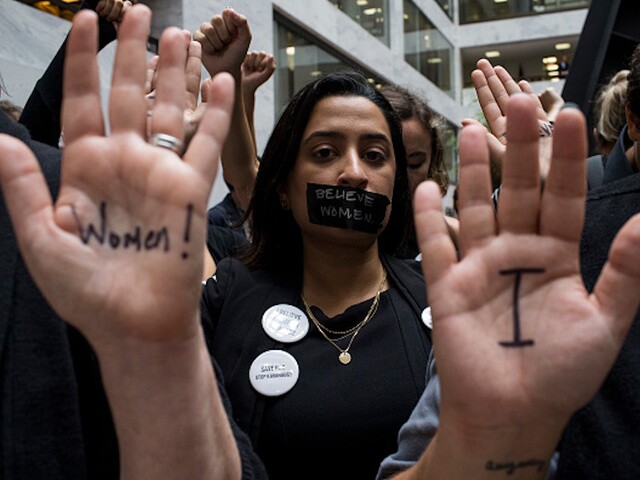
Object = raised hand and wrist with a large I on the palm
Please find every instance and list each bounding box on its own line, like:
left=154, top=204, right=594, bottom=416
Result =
left=398, top=95, right=640, bottom=479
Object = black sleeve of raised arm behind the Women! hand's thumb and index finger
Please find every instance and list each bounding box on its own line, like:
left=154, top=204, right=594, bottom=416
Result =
left=20, top=0, right=116, bottom=148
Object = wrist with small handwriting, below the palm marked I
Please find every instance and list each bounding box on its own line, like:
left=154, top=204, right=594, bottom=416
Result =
left=393, top=416, right=565, bottom=480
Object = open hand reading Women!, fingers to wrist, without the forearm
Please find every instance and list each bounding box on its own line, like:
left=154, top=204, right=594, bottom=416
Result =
left=0, top=6, right=233, bottom=345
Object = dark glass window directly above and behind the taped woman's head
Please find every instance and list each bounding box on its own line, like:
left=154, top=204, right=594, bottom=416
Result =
left=275, top=19, right=382, bottom=118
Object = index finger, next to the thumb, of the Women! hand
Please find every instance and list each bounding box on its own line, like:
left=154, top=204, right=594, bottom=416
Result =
left=62, top=10, right=104, bottom=144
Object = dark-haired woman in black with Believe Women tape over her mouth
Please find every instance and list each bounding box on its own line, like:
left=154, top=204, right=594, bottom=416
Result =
left=201, top=67, right=431, bottom=478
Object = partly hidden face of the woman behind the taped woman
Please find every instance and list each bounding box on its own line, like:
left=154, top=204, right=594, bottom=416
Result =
left=402, top=118, right=431, bottom=198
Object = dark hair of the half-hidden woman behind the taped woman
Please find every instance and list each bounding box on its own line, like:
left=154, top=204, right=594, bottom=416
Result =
left=380, top=85, right=449, bottom=195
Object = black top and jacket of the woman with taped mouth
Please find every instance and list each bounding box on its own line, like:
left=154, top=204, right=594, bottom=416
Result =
left=201, top=253, right=431, bottom=479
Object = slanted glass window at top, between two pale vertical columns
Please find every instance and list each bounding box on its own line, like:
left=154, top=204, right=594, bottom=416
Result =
left=404, top=0, right=454, bottom=97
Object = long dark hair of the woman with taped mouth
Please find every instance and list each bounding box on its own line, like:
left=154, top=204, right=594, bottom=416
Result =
left=242, top=71, right=411, bottom=269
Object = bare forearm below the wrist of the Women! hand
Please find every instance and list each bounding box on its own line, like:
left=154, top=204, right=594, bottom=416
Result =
left=97, top=320, right=241, bottom=479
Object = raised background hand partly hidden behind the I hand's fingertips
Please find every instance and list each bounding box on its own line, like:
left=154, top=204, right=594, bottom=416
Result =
left=462, top=59, right=552, bottom=187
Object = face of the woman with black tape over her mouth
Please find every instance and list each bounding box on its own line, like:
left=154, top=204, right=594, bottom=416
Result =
left=281, top=96, right=396, bottom=242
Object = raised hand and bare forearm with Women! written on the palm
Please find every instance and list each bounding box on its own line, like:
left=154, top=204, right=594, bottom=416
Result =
left=0, top=5, right=241, bottom=480
